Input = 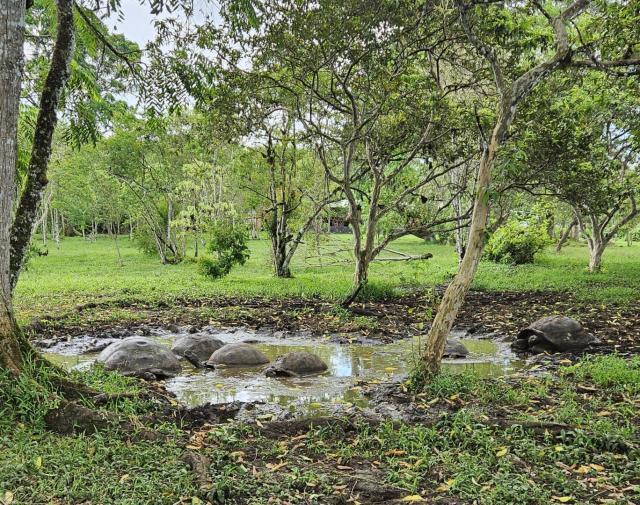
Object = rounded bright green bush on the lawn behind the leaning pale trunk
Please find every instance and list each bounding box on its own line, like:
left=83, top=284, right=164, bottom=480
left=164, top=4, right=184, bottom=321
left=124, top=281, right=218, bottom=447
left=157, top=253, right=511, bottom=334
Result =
left=485, top=220, right=550, bottom=265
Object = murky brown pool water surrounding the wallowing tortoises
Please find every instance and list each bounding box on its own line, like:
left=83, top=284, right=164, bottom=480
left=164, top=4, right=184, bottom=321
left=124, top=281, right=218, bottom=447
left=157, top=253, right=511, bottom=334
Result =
left=46, top=330, right=523, bottom=408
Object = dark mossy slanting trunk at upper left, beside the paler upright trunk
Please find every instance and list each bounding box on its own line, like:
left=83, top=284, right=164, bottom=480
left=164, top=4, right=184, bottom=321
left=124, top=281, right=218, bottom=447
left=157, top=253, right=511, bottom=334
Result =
left=11, top=0, right=75, bottom=289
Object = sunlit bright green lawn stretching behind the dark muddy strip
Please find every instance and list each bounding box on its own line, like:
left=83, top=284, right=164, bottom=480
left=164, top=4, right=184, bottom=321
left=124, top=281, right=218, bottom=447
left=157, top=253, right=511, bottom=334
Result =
left=16, top=235, right=640, bottom=321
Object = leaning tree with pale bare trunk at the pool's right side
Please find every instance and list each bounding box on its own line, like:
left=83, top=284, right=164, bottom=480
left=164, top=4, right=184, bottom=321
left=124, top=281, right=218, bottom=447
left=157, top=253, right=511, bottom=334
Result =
left=423, top=0, right=640, bottom=374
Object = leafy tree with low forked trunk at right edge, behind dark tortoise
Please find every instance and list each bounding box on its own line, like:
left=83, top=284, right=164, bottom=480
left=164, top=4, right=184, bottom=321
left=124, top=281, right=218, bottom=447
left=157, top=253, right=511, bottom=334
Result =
left=514, top=71, right=640, bottom=272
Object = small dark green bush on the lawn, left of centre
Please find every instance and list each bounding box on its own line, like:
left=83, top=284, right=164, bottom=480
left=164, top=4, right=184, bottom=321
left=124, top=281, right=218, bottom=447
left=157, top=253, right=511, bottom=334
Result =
left=198, top=225, right=250, bottom=279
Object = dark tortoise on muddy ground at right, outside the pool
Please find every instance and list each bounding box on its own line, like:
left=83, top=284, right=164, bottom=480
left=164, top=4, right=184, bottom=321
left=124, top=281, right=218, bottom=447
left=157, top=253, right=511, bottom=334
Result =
left=511, top=316, right=600, bottom=354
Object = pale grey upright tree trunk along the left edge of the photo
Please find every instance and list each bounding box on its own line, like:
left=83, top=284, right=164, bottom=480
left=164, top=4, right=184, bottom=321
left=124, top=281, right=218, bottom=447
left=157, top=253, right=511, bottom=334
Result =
left=0, top=0, right=25, bottom=373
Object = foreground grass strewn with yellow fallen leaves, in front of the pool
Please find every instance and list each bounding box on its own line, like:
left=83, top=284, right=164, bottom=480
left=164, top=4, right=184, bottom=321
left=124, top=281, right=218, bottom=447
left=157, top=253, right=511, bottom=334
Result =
left=0, top=355, right=640, bottom=505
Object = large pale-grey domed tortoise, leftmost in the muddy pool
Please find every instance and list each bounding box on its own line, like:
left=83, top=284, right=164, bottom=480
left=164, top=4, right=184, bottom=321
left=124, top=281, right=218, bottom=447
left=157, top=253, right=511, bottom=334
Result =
left=96, top=337, right=182, bottom=379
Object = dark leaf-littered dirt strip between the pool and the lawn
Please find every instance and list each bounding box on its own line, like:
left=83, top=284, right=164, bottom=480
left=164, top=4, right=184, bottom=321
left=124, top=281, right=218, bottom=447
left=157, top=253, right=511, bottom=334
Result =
left=25, top=291, right=640, bottom=353
